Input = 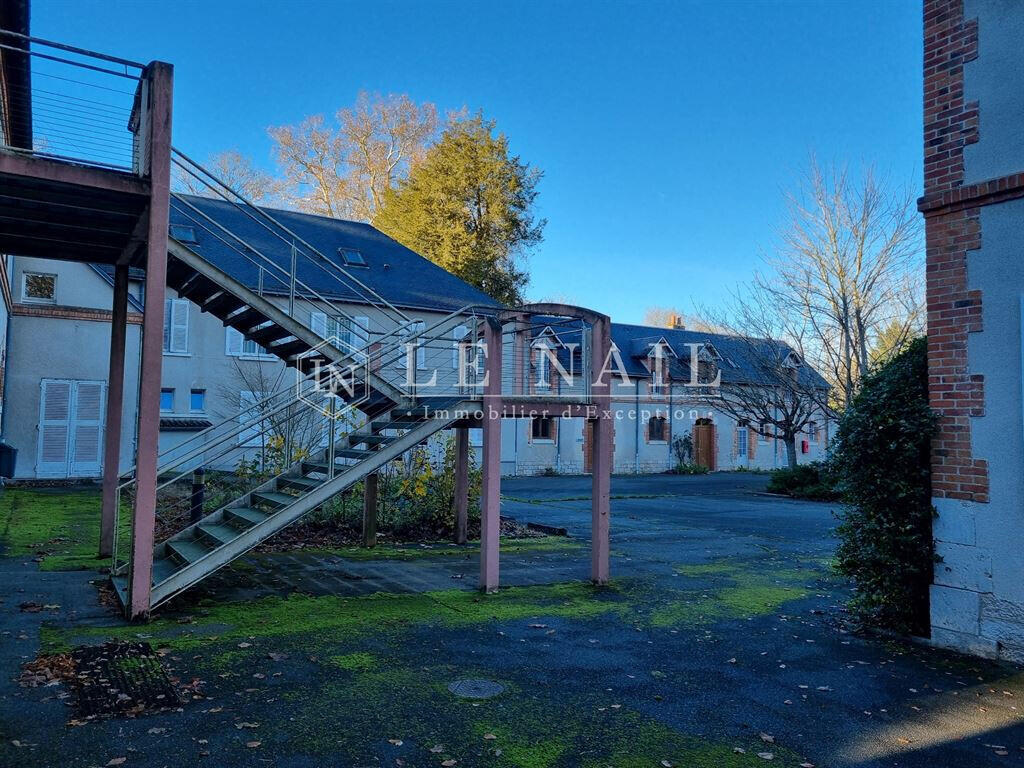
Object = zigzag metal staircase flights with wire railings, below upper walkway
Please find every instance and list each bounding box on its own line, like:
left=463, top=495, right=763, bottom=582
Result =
left=112, top=153, right=480, bottom=610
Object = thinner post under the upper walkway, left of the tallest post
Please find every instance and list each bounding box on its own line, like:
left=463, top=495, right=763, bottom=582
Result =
left=99, top=264, right=128, bottom=557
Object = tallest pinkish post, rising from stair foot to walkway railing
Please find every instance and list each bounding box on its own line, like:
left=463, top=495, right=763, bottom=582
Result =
left=128, top=61, right=173, bottom=618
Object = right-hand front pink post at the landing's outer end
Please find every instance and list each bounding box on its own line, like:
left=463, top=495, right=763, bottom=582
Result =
left=590, top=317, right=614, bottom=584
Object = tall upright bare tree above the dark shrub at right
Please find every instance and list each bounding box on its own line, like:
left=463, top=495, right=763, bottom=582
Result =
left=755, top=158, right=924, bottom=408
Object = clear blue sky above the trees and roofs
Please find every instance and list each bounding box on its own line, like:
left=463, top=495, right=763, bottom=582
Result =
left=32, top=0, right=923, bottom=322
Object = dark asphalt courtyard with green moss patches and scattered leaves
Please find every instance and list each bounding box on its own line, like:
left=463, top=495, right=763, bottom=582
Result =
left=0, top=473, right=1024, bottom=768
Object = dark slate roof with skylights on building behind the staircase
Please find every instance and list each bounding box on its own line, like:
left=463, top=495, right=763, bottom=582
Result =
left=170, top=195, right=500, bottom=311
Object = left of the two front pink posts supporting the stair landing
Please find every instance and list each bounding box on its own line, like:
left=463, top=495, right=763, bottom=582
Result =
left=480, top=317, right=502, bottom=592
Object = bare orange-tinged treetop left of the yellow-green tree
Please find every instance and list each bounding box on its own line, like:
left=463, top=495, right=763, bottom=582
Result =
left=268, top=92, right=439, bottom=221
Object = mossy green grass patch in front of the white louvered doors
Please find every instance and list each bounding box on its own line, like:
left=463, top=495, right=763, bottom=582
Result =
left=0, top=488, right=110, bottom=570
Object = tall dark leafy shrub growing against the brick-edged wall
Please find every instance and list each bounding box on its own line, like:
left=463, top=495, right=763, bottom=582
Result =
left=831, top=338, right=936, bottom=634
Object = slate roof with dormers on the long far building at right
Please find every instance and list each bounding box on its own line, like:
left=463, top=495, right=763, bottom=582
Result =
left=611, top=323, right=828, bottom=388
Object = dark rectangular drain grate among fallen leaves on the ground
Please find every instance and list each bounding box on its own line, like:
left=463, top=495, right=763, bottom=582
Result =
left=72, top=643, right=181, bottom=718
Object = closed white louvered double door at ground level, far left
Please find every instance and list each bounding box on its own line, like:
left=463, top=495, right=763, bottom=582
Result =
left=36, top=379, right=105, bottom=477
